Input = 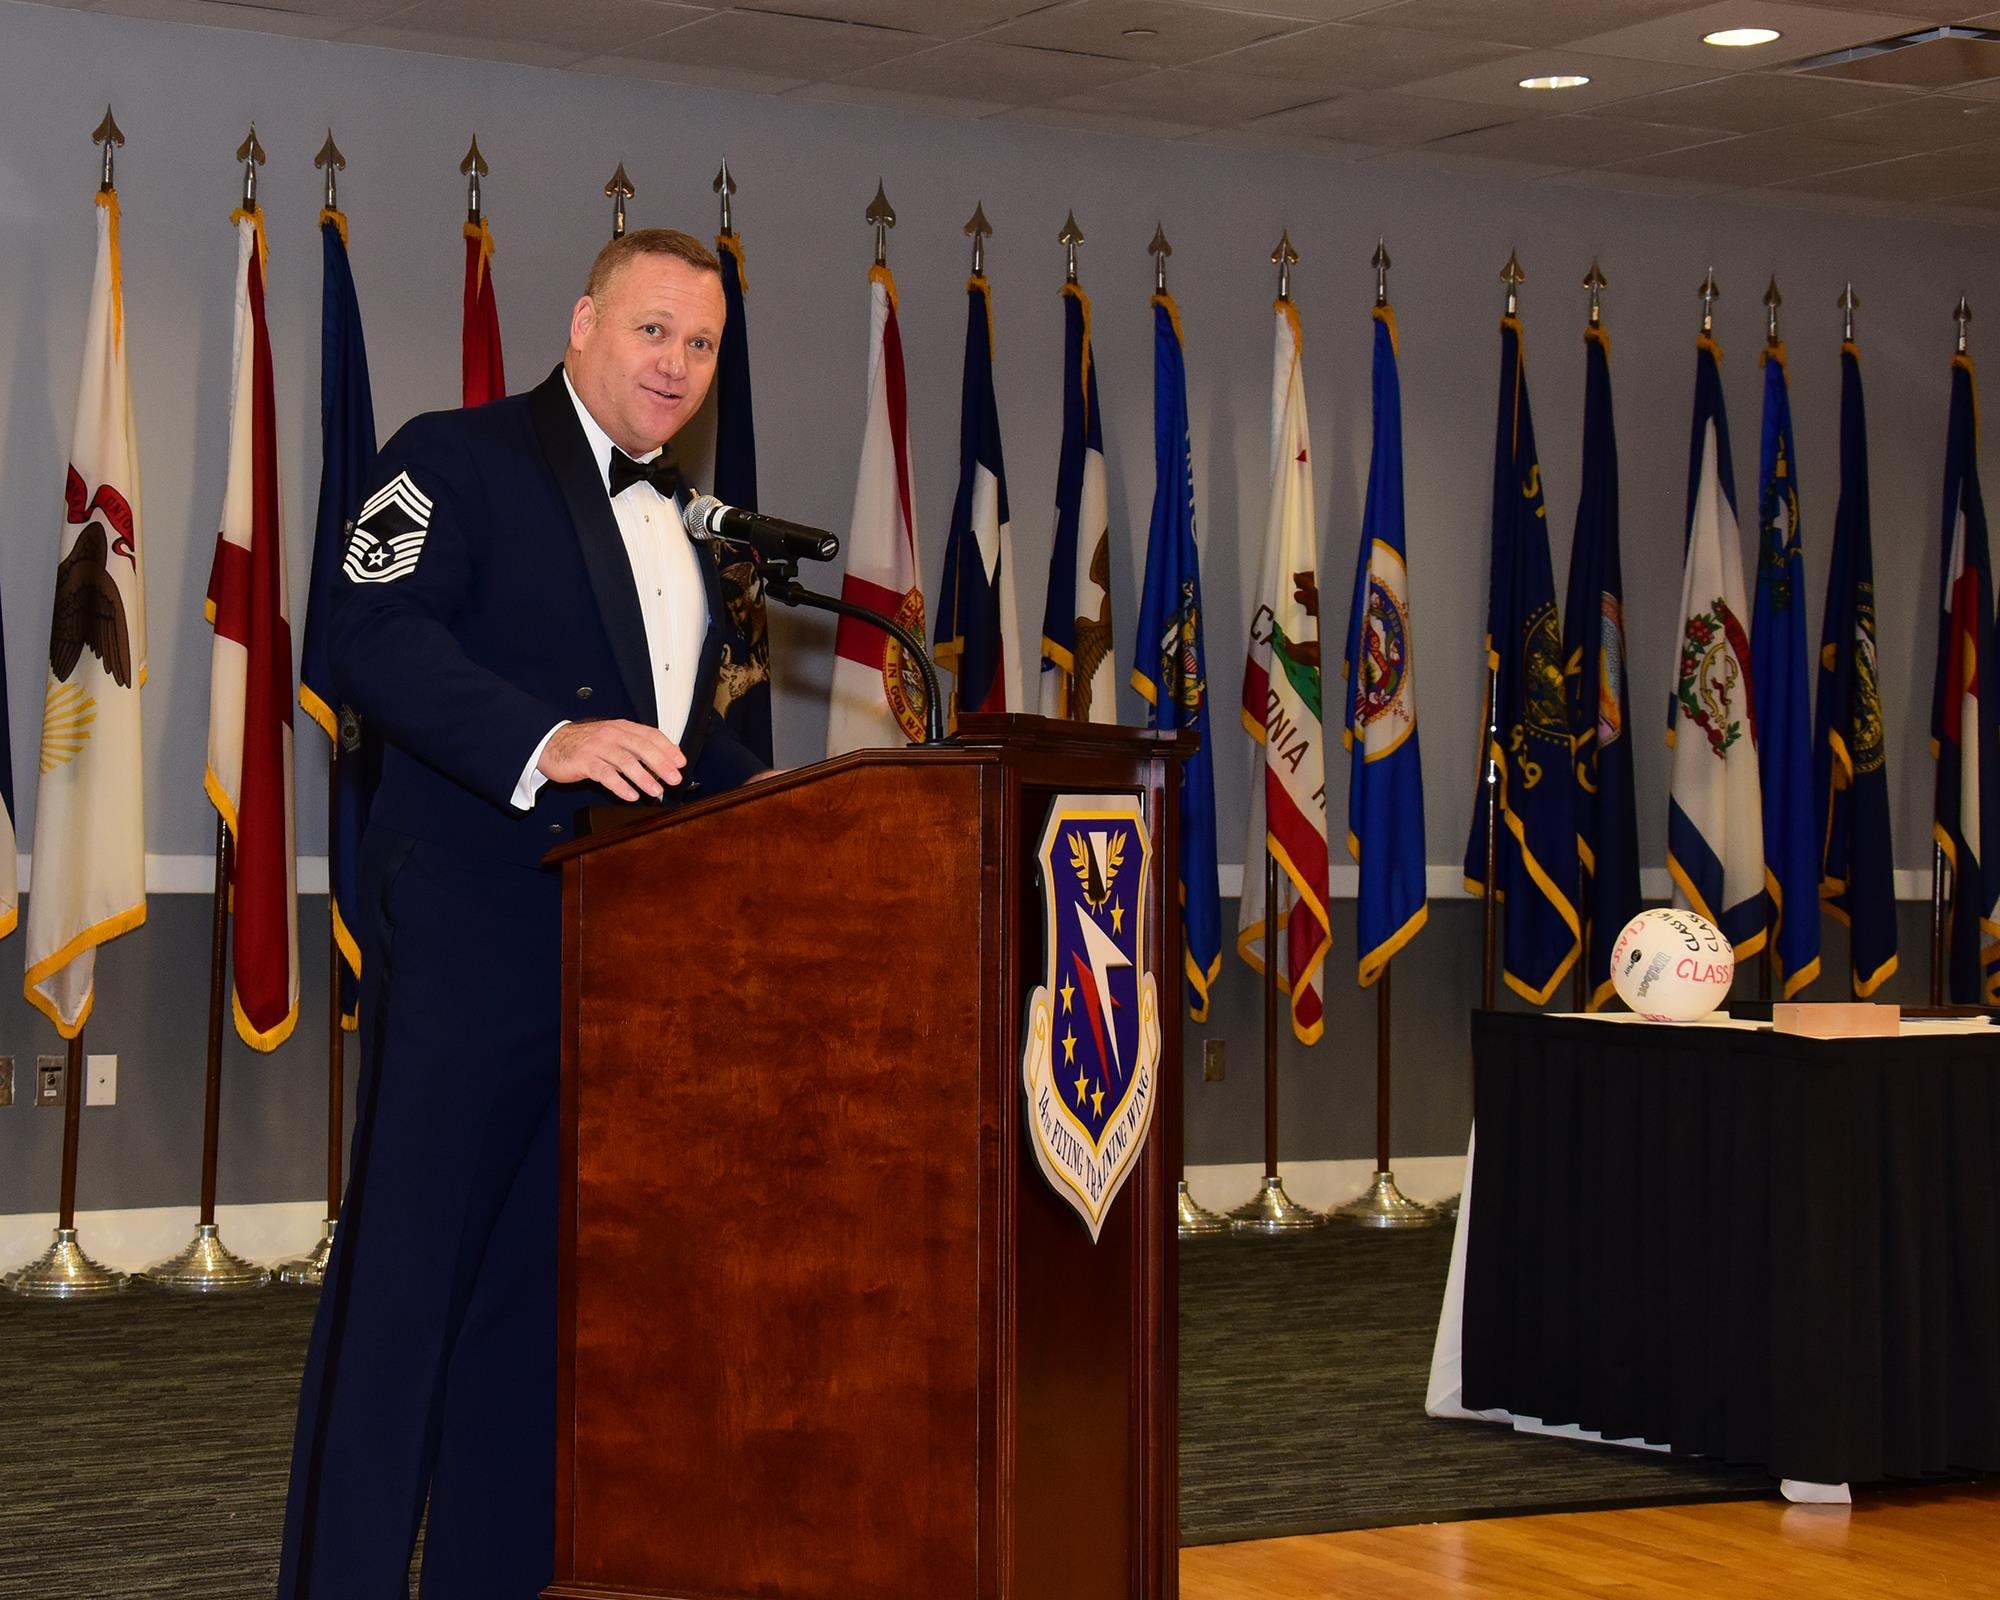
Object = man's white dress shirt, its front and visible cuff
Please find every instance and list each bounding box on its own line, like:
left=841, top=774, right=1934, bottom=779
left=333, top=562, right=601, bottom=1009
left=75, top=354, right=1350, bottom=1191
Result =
left=514, top=372, right=708, bottom=810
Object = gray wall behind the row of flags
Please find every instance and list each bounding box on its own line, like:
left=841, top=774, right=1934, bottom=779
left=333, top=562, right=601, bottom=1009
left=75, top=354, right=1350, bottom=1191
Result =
left=0, top=0, right=1996, bottom=1210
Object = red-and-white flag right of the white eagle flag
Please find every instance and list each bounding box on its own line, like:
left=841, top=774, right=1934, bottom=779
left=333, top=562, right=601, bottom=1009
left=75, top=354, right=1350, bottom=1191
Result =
left=204, top=208, right=298, bottom=1050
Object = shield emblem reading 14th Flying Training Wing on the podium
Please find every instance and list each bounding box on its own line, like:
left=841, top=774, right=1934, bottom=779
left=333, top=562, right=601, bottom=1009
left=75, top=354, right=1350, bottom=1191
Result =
left=1022, top=794, right=1160, bottom=1240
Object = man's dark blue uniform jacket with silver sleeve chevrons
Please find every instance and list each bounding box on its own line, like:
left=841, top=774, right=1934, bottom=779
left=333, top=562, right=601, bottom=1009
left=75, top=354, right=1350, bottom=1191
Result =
left=330, top=368, right=764, bottom=864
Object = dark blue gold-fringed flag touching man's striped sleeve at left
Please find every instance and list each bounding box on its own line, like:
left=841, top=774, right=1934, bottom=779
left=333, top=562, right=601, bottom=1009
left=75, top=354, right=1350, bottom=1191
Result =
left=298, top=210, right=382, bottom=1028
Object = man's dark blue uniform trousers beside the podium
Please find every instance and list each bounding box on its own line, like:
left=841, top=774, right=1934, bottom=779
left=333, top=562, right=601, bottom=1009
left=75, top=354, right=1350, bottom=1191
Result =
left=278, top=826, right=562, bottom=1600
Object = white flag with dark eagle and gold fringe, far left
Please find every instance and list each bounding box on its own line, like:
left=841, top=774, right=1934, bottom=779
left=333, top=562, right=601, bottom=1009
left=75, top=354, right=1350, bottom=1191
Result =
left=24, top=190, right=146, bottom=1038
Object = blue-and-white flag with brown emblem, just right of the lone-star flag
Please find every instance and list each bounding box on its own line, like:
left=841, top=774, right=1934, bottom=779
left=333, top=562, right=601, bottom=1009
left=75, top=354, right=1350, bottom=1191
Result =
left=1042, top=284, right=1118, bottom=722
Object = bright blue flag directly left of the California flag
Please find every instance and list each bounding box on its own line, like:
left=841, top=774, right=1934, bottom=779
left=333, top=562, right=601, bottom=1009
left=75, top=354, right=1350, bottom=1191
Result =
left=1132, top=290, right=1222, bottom=1022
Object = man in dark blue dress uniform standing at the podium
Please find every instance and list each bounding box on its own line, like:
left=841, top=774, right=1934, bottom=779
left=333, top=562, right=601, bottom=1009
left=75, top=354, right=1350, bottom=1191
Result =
left=278, top=228, right=760, bottom=1600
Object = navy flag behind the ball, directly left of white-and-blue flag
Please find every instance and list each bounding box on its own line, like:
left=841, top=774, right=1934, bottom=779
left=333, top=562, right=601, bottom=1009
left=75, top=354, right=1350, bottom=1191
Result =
left=1562, top=324, right=1640, bottom=1010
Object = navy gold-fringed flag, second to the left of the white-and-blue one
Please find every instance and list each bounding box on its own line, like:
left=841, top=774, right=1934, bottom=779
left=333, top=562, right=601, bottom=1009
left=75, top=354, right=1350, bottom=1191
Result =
left=1466, top=316, right=1578, bottom=1006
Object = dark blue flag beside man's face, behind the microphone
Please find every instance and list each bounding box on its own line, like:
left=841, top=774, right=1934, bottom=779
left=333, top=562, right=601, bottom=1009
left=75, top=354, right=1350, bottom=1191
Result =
left=714, top=232, right=772, bottom=762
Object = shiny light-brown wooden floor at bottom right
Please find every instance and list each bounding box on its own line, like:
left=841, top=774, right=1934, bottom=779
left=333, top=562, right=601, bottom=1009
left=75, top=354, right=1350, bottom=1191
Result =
left=1180, top=1484, right=2000, bottom=1600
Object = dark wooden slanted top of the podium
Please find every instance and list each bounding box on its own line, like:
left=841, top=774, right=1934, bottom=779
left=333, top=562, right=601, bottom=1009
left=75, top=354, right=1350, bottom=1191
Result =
left=542, top=712, right=1198, bottom=866
